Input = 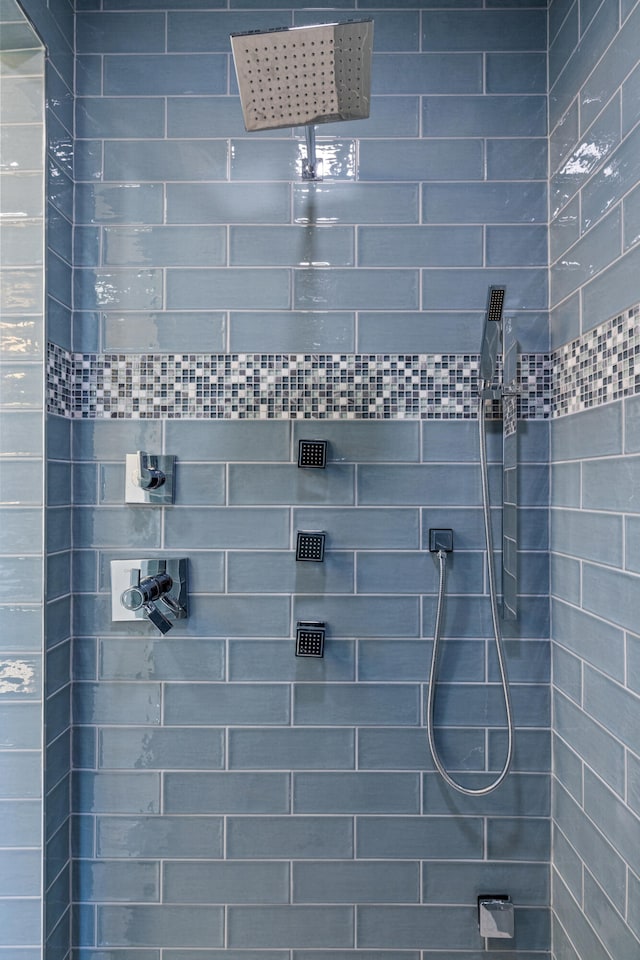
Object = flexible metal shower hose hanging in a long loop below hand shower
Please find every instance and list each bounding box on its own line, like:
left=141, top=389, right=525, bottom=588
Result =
left=427, top=382, right=514, bottom=797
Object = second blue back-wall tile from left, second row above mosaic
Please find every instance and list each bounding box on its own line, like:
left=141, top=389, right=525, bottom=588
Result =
left=166, top=267, right=290, bottom=310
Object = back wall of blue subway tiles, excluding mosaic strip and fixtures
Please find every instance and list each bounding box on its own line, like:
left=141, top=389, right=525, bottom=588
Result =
left=69, top=0, right=549, bottom=960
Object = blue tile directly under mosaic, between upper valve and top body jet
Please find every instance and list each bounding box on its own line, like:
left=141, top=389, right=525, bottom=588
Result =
left=164, top=421, right=291, bottom=464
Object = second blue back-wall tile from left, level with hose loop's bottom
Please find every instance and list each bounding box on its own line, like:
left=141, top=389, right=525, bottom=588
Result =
left=164, top=772, right=289, bottom=812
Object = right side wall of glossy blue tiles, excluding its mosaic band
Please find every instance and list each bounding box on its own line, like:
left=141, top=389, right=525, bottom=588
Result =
left=549, top=0, right=640, bottom=960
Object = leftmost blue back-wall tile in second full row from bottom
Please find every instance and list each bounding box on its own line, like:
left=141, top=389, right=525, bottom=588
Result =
left=72, top=858, right=160, bottom=903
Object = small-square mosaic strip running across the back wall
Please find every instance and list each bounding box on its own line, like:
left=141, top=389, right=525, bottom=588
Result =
left=48, top=344, right=551, bottom=420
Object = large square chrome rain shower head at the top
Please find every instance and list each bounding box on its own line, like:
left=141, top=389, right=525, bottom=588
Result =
left=231, top=19, right=373, bottom=130
